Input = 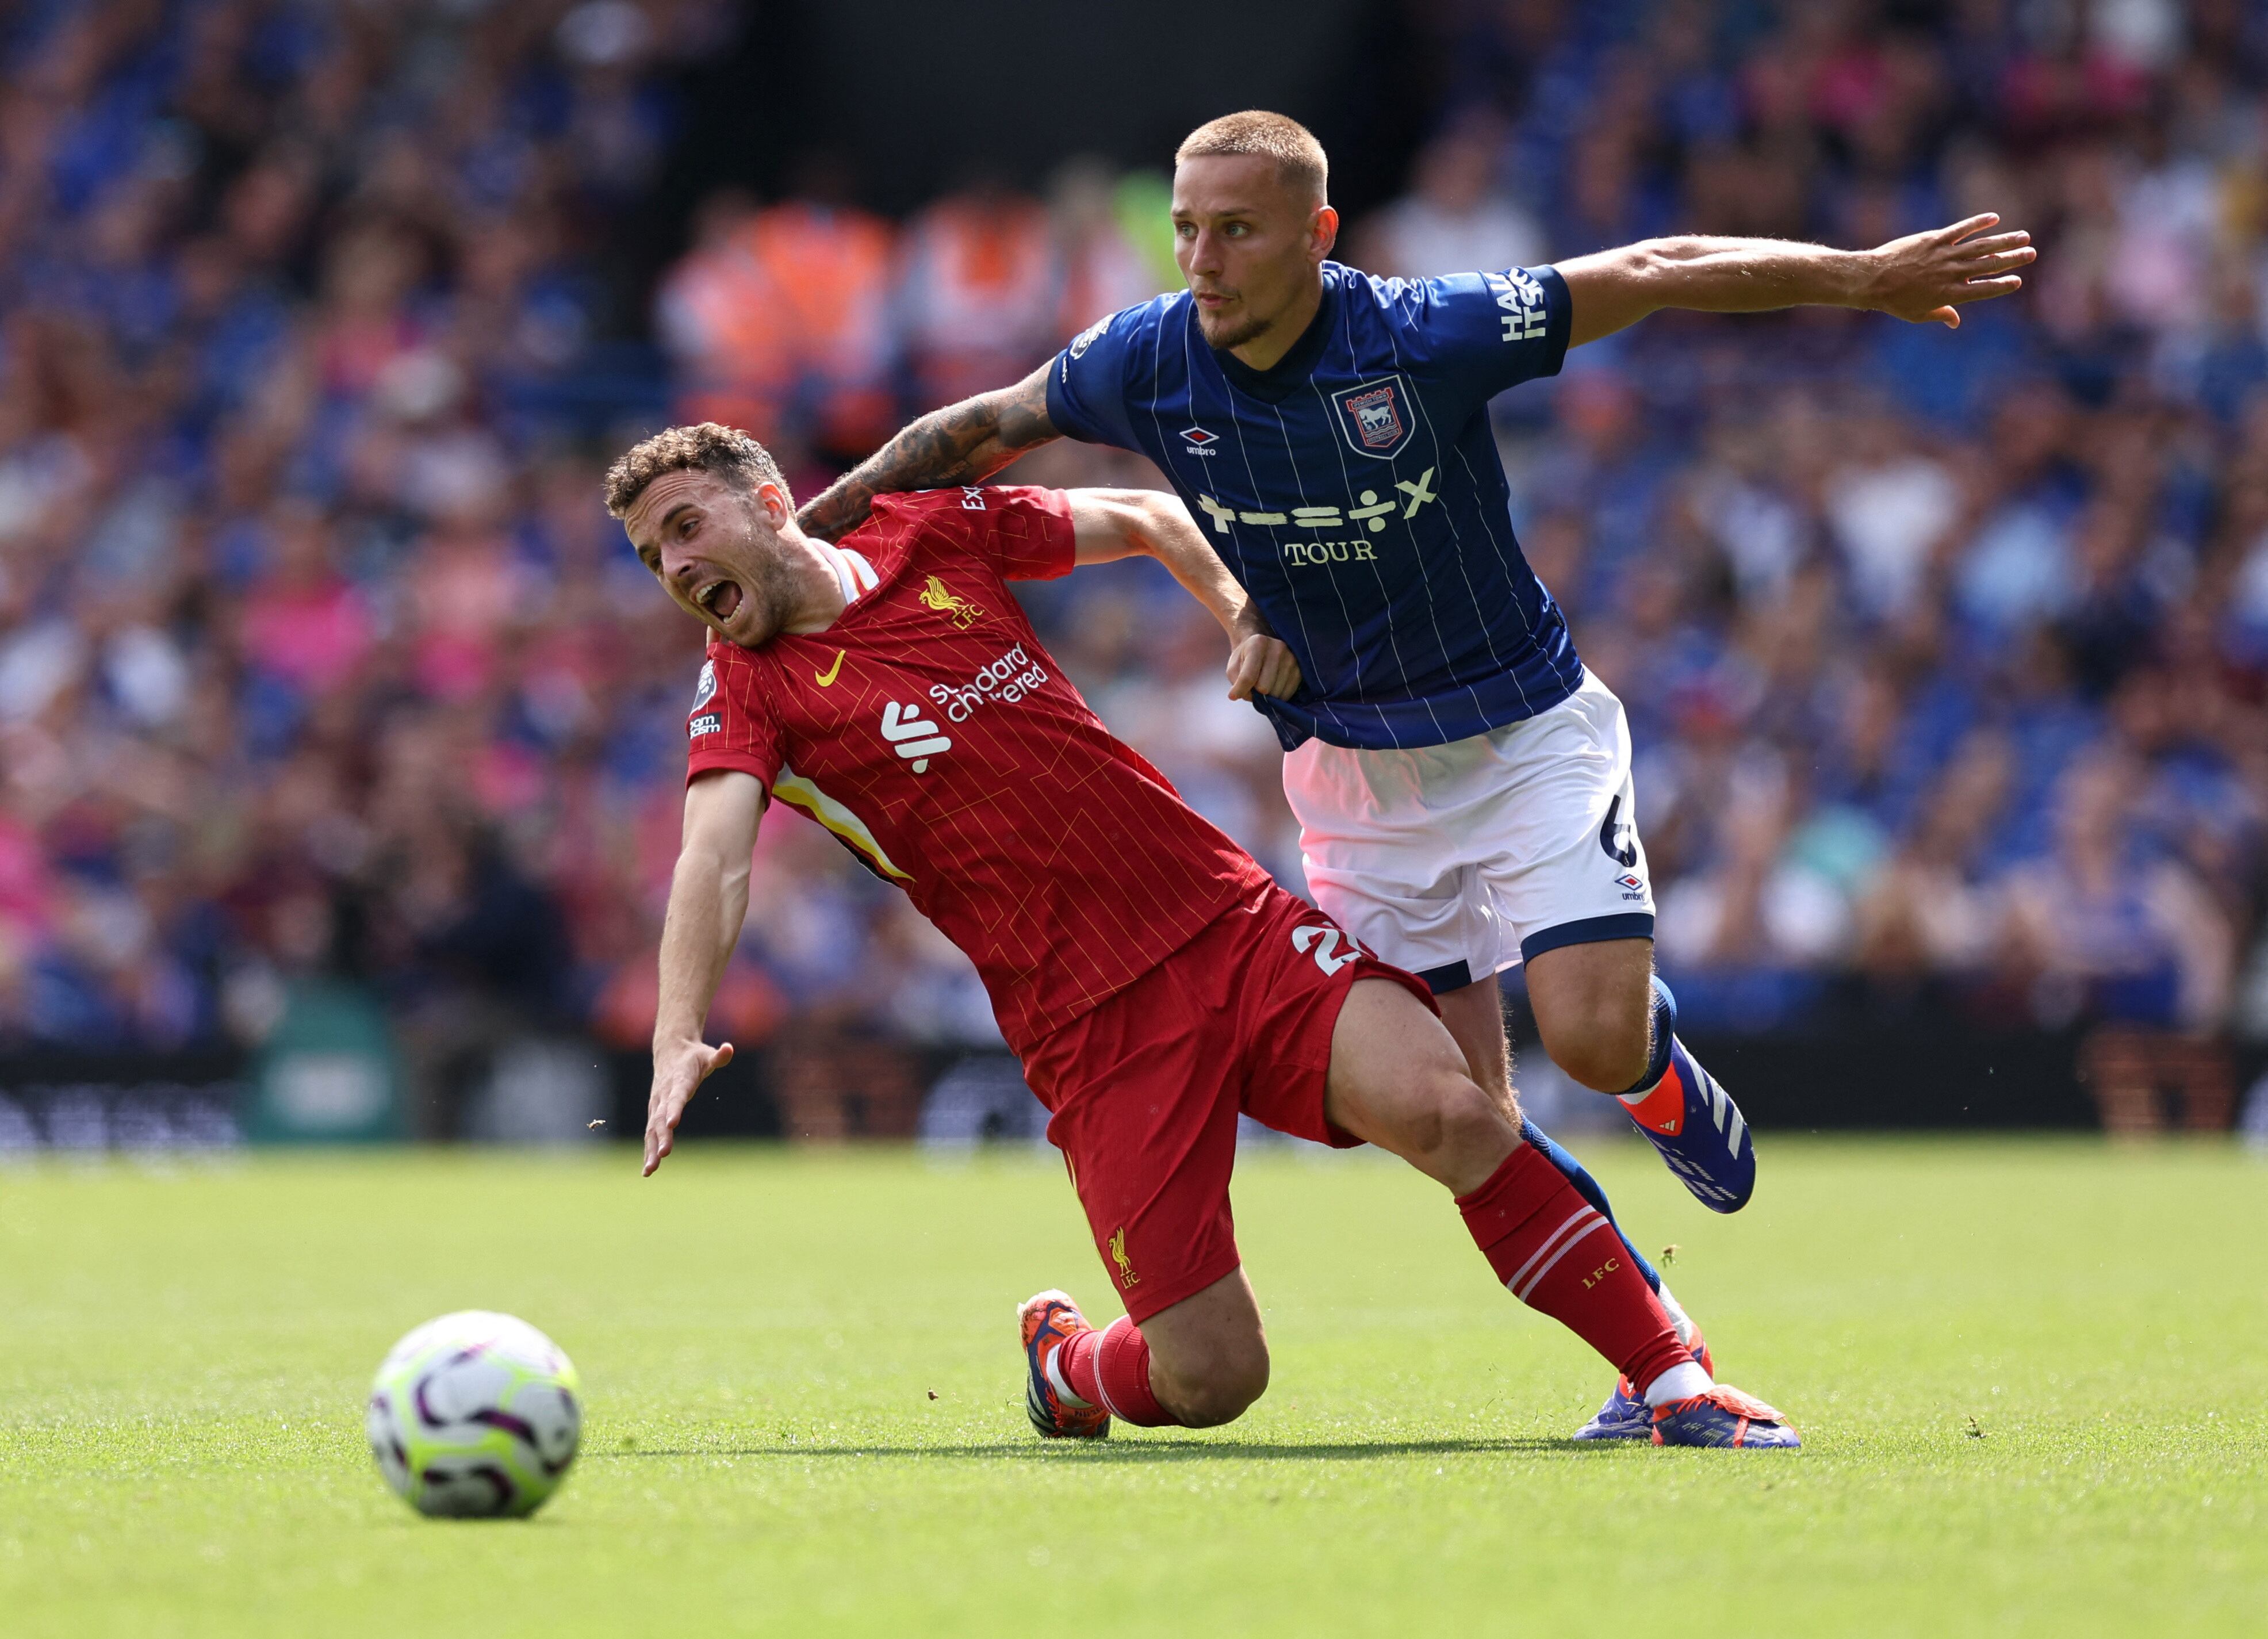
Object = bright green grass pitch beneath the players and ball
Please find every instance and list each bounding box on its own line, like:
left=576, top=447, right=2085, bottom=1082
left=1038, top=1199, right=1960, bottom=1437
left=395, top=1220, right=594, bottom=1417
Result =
left=0, top=1136, right=2268, bottom=1639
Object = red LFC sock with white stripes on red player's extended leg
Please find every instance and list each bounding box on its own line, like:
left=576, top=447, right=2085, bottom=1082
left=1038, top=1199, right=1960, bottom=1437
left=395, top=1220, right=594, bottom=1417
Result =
left=1456, top=1145, right=1692, bottom=1392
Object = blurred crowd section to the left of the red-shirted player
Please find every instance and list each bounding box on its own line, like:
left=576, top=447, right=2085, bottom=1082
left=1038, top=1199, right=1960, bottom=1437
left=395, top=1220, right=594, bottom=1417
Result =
left=0, top=0, right=737, bottom=1115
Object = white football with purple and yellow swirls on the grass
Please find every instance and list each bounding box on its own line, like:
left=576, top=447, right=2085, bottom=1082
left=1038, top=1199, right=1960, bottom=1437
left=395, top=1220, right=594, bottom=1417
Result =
left=365, top=1308, right=583, bottom=1519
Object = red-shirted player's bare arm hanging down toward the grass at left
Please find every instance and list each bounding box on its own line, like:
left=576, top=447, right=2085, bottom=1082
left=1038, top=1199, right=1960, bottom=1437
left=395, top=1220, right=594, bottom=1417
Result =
left=644, top=768, right=764, bottom=1179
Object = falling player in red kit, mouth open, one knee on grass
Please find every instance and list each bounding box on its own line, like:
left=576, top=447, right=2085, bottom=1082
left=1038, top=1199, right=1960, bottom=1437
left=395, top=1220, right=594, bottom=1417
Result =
left=606, top=424, right=1796, bottom=1446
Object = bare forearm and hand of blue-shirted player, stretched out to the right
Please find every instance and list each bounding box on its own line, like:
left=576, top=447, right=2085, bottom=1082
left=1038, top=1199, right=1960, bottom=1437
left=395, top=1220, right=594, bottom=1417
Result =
left=1558, top=213, right=2039, bottom=347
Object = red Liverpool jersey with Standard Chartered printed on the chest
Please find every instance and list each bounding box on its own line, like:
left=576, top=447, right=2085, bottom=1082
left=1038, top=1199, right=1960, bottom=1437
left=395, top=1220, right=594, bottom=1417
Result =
left=687, top=485, right=1268, bottom=1050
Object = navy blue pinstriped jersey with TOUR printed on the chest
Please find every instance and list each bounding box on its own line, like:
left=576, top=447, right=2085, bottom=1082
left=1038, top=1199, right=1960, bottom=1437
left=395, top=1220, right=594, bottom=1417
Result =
left=1048, top=263, right=1583, bottom=748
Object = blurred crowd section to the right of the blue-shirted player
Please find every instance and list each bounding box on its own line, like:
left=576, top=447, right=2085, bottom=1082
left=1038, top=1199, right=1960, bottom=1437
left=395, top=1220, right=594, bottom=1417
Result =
left=1388, top=0, right=2268, bottom=1124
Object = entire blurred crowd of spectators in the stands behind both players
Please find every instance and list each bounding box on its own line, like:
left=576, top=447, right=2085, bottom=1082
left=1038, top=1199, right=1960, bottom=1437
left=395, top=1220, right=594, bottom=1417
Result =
left=0, top=0, right=2268, bottom=1122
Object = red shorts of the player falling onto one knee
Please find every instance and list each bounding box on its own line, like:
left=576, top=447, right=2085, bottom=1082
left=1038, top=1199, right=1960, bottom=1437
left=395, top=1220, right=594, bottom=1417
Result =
left=1023, top=884, right=1438, bottom=1322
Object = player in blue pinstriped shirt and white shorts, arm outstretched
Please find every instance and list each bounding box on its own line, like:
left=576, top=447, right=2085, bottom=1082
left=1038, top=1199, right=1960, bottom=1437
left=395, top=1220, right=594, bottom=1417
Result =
left=800, top=111, right=2035, bottom=1437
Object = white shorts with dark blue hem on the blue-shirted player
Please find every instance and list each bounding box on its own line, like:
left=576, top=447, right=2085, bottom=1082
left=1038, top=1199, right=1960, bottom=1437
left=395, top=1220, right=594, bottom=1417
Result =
left=1284, top=671, right=1653, bottom=995
